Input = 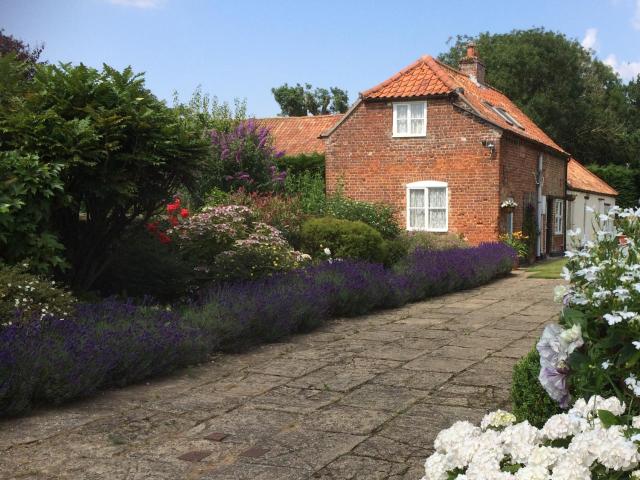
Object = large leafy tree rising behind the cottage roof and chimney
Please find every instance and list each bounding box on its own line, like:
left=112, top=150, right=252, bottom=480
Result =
left=440, top=28, right=638, bottom=169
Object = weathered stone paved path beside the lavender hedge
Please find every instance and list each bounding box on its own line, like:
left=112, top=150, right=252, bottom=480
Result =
left=0, top=272, right=558, bottom=480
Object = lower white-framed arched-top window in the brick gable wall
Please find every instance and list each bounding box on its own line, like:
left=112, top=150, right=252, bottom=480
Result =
left=407, top=181, right=449, bottom=232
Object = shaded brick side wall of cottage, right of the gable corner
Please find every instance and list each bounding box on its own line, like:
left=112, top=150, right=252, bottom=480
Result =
left=500, top=134, right=566, bottom=253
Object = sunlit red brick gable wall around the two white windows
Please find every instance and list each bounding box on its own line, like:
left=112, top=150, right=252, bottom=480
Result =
left=326, top=98, right=500, bottom=243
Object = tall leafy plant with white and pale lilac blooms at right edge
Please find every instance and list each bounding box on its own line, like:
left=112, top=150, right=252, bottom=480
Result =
left=538, top=207, right=640, bottom=411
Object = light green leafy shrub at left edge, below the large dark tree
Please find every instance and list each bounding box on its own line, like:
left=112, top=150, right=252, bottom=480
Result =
left=0, top=150, right=66, bottom=272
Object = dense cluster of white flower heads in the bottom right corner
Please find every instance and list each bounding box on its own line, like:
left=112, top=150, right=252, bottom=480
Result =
left=423, top=396, right=640, bottom=480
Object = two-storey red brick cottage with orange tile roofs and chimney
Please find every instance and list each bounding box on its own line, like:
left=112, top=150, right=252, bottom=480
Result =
left=263, top=44, right=569, bottom=256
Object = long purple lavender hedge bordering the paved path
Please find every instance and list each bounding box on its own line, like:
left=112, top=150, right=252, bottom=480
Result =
left=0, top=243, right=515, bottom=416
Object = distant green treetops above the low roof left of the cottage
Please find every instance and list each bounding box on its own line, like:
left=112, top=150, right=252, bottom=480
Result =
left=271, top=83, right=349, bottom=117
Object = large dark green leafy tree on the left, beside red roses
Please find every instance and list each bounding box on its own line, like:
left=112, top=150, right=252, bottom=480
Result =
left=0, top=58, right=209, bottom=289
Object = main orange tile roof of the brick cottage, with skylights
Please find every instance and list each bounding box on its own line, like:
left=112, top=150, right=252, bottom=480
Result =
left=362, top=55, right=566, bottom=154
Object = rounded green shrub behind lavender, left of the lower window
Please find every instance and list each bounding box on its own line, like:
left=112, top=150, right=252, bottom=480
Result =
left=302, top=217, right=384, bottom=262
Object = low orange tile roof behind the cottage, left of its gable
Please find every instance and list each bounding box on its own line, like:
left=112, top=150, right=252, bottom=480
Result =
left=256, top=114, right=344, bottom=155
